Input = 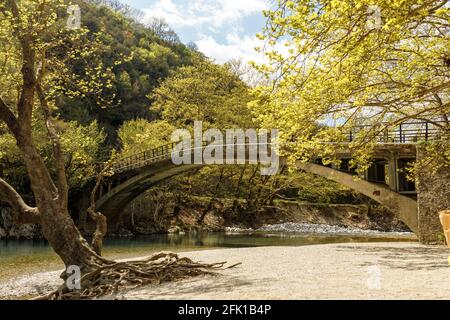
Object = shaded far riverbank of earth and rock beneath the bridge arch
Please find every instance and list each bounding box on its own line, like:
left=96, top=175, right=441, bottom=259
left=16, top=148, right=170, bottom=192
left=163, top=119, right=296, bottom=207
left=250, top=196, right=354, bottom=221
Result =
left=0, top=197, right=409, bottom=240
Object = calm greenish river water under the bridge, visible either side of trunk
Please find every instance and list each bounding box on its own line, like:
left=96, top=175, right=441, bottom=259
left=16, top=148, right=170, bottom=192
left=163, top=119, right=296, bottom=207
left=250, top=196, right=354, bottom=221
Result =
left=0, top=232, right=414, bottom=282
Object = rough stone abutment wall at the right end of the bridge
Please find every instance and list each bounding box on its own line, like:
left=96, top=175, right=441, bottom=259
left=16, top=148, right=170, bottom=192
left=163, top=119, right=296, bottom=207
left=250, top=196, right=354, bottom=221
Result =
left=417, top=147, right=450, bottom=244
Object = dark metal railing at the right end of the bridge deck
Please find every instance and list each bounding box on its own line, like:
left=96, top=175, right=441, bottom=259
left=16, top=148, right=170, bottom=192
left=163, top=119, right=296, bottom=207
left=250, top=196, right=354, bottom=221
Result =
left=347, top=121, right=447, bottom=144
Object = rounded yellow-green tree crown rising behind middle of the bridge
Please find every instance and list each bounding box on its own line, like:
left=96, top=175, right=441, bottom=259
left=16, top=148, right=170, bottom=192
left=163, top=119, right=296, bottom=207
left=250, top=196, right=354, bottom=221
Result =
left=149, top=57, right=253, bottom=129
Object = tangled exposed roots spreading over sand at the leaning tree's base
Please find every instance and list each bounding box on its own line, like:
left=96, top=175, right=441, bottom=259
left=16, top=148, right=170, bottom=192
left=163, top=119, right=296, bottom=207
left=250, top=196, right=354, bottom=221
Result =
left=37, top=253, right=240, bottom=300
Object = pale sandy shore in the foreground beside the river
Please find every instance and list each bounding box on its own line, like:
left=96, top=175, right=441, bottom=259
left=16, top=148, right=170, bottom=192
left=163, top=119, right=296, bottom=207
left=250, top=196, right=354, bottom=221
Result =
left=0, top=243, right=450, bottom=300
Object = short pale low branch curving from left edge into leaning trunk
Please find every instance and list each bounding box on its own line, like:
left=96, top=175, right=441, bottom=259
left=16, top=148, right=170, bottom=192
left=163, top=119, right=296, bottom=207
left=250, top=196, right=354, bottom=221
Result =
left=0, top=178, right=41, bottom=224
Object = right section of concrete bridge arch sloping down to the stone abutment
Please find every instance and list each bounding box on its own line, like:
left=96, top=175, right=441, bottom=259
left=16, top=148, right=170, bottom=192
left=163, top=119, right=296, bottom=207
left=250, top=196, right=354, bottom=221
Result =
left=296, top=161, right=419, bottom=234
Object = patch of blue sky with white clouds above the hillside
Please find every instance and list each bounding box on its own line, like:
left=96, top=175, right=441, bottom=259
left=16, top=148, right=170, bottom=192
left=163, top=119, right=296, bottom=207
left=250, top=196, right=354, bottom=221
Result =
left=121, top=0, right=270, bottom=63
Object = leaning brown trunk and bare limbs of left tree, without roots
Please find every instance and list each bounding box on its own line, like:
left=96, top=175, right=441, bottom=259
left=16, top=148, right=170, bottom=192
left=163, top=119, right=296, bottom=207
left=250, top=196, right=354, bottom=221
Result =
left=0, top=0, right=110, bottom=277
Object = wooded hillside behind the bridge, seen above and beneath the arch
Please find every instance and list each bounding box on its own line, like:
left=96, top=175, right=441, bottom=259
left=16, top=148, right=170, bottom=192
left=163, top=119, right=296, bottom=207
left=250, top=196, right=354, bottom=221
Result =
left=0, top=0, right=366, bottom=238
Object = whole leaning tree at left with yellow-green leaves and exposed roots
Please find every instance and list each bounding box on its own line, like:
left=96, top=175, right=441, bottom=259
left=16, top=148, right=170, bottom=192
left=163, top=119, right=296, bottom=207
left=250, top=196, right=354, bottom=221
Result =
left=0, top=0, right=222, bottom=297
